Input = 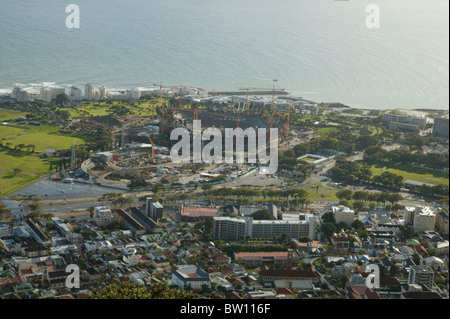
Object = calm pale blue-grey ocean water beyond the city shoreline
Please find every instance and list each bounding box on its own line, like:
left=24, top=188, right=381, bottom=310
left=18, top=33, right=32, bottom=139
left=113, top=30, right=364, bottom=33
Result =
left=0, top=0, right=449, bottom=109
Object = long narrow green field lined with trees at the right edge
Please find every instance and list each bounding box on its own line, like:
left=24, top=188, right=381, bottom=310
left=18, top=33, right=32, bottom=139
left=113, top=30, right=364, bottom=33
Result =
left=371, top=165, right=449, bottom=185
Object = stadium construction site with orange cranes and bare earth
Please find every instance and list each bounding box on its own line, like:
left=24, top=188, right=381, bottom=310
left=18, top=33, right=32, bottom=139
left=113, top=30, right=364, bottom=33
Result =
left=69, top=85, right=316, bottom=189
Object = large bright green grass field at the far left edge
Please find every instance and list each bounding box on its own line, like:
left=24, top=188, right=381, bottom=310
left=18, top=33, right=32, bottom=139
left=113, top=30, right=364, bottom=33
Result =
left=0, top=125, right=86, bottom=196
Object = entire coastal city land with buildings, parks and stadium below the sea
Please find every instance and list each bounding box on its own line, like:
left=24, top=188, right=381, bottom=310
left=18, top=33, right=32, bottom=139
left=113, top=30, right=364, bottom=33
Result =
left=0, top=84, right=449, bottom=300
